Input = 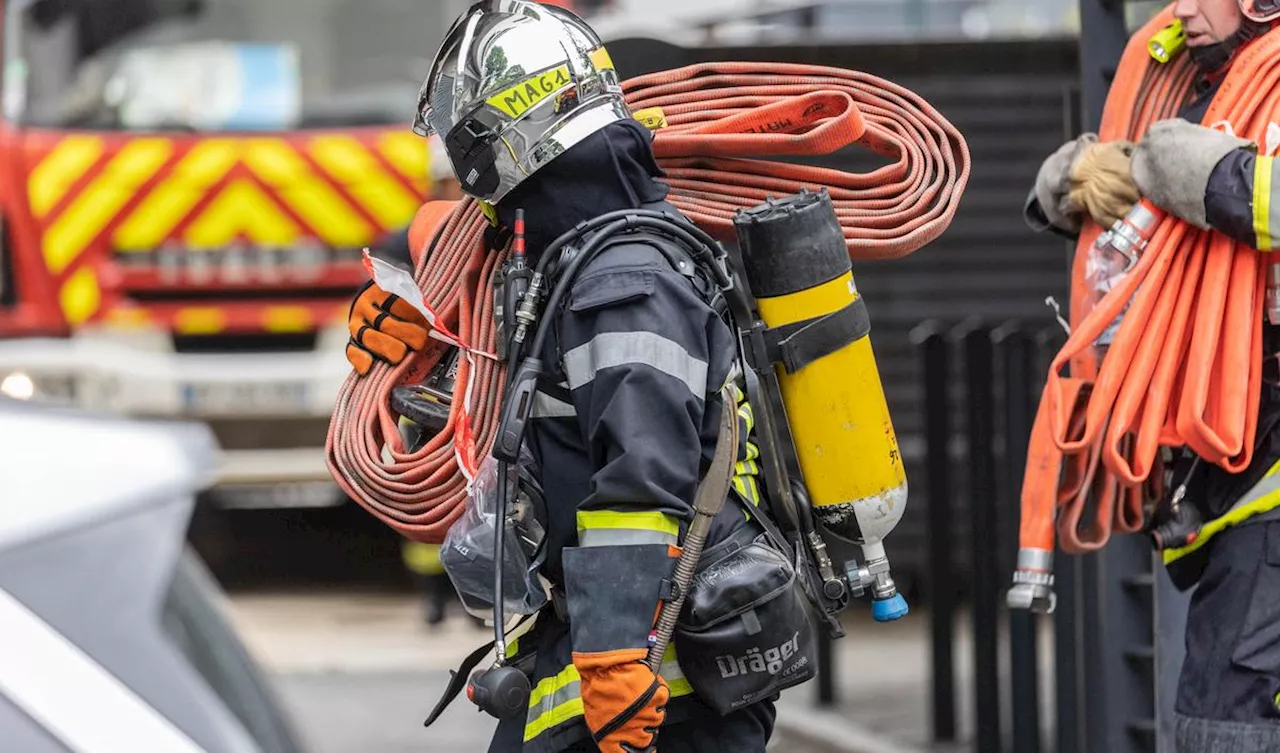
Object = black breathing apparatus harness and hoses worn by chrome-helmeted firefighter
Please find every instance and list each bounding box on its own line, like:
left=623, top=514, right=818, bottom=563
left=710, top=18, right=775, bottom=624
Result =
left=425, top=197, right=867, bottom=726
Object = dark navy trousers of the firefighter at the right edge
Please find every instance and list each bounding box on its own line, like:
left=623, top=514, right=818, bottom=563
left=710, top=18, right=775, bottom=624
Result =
left=1176, top=521, right=1280, bottom=753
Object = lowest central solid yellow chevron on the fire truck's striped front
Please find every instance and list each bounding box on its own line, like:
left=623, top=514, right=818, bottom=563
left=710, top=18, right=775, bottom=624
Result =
left=183, top=179, right=300, bottom=248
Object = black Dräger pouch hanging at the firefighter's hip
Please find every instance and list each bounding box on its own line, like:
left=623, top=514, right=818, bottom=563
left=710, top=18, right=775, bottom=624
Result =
left=673, top=522, right=817, bottom=715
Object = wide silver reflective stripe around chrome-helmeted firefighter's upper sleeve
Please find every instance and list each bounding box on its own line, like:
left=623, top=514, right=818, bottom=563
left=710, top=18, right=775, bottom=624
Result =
left=564, top=332, right=707, bottom=400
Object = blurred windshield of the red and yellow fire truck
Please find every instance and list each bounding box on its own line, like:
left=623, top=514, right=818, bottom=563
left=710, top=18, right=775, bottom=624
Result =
left=4, top=0, right=434, bottom=131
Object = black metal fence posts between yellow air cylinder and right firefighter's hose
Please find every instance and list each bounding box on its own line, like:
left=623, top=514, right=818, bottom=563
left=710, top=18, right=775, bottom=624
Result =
left=911, top=319, right=1070, bottom=753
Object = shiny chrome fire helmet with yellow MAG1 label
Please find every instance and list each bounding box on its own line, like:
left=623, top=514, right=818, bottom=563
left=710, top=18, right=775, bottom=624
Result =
left=413, top=0, right=631, bottom=204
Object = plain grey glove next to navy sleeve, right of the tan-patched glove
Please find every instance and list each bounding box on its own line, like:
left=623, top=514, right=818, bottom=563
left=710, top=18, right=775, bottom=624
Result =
left=1132, top=118, right=1258, bottom=231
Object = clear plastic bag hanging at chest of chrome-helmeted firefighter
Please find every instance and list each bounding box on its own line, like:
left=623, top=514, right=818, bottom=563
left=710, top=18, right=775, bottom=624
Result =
left=440, top=452, right=548, bottom=619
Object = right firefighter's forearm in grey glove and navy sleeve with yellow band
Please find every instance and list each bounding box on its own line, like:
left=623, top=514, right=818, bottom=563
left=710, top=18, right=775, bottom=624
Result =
left=1133, top=119, right=1272, bottom=236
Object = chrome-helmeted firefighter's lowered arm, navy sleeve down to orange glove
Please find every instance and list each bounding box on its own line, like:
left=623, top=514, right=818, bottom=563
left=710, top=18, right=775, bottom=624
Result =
left=561, top=246, right=723, bottom=753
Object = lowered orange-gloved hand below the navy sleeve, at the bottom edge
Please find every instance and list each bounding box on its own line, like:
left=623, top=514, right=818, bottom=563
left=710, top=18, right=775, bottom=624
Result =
left=573, top=648, right=671, bottom=753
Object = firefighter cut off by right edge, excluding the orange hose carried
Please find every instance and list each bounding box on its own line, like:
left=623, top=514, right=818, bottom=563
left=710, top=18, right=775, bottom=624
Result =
left=1027, top=0, right=1280, bottom=753
